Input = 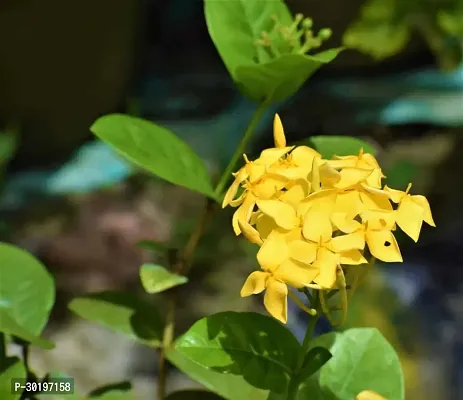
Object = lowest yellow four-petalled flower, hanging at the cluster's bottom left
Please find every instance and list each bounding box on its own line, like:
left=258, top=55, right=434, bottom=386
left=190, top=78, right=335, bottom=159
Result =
left=241, top=232, right=318, bottom=323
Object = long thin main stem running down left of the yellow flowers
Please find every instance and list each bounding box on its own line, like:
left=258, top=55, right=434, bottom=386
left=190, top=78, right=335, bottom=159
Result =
left=157, top=101, right=268, bottom=400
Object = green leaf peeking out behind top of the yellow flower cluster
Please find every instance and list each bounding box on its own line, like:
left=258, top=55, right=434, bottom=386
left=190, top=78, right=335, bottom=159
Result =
left=307, top=135, right=376, bottom=159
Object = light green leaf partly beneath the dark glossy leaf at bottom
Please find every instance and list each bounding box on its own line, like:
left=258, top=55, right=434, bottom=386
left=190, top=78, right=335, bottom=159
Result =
left=167, top=349, right=284, bottom=400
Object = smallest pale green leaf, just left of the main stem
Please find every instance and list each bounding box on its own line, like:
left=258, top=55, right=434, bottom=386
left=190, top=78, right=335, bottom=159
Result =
left=140, top=264, right=188, bottom=294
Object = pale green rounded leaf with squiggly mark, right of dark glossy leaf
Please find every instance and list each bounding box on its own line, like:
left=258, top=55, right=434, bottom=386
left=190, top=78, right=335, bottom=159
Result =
left=312, top=328, right=405, bottom=400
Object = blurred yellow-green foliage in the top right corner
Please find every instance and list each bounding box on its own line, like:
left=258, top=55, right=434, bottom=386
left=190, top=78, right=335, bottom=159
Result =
left=344, top=0, right=463, bottom=69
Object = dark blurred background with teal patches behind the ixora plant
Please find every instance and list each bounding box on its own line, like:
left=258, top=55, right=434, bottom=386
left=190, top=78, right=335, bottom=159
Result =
left=0, top=0, right=463, bottom=400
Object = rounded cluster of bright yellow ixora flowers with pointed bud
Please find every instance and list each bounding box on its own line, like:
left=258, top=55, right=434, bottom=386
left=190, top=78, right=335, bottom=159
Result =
left=222, top=115, right=435, bottom=323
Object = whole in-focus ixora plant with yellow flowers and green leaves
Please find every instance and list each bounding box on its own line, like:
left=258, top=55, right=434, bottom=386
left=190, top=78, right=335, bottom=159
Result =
left=0, top=0, right=435, bottom=400
